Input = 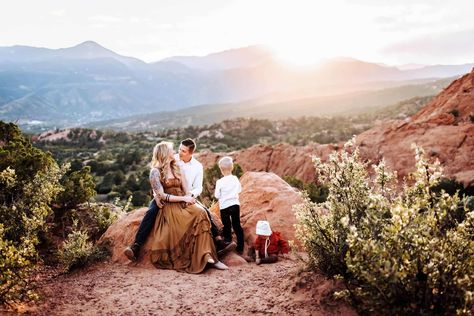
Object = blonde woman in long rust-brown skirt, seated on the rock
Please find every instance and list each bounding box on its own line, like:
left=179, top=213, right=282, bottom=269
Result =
left=150, top=142, right=227, bottom=273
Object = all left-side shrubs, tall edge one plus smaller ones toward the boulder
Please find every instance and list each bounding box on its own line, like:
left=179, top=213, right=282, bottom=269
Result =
left=0, top=121, right=119, bottom=304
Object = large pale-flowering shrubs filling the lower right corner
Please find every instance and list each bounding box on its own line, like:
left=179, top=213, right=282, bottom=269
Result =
left=296, top=142, right=474, bottom=315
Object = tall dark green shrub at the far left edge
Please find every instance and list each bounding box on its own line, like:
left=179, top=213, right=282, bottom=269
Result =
left=0, top=121, right=65, bottom=304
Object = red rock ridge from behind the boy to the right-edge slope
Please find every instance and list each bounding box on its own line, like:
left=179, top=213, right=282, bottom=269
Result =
left=198, top=70, right=474, bottom=187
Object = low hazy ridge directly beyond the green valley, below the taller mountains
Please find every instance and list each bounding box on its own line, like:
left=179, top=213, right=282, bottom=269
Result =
left=87, top=78, right=452, bottom=131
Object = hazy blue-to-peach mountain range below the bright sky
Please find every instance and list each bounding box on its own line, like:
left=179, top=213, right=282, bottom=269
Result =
left=0, top=41, right=474, bottom=130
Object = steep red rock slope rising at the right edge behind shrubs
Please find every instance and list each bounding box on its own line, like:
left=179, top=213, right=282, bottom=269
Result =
left=357, top=70, right=474, bottom=186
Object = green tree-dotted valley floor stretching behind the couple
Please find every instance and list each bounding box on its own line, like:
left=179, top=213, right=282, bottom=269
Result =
left=36, top=97, right=431, bottom=206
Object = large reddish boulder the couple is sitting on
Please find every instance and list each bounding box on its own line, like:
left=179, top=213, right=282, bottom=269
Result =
left=99, top=172, right=302, bottom=267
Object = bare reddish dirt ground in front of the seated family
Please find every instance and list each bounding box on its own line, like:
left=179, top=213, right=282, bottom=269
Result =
left=6, top=257, right=356, bottom=315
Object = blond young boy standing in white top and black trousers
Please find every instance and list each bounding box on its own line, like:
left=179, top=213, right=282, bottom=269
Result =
left=214, top=157, right=244, bottom=254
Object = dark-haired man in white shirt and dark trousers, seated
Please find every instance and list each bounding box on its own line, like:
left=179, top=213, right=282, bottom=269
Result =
left=124, top=138, right=236, bottom=261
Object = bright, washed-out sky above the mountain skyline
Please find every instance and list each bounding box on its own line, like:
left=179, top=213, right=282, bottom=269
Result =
left=0, top=0, right=474, bottom=65
